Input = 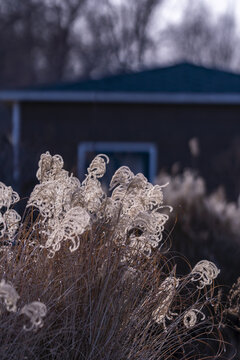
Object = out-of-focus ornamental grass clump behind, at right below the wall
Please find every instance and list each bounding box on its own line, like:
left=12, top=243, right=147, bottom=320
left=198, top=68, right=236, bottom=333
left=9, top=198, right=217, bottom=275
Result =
left=157, top=169, right=240, bottom=286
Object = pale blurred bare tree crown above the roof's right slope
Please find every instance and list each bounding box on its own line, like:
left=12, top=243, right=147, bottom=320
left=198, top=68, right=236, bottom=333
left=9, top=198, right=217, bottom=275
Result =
left=165, top=3, right=239, bottom=68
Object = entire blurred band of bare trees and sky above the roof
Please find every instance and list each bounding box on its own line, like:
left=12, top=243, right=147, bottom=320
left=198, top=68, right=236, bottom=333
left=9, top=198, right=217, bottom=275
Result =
left=0, top=0, right=240, bottom=88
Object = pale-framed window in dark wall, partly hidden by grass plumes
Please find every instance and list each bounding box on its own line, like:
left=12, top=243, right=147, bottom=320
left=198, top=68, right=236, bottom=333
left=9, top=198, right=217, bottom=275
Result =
left=78, top=142, right=157, bottom=185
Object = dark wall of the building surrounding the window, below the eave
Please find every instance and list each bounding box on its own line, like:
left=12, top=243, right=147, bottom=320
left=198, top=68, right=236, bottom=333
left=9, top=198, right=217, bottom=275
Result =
left=21, top=103, right=240, bottom=198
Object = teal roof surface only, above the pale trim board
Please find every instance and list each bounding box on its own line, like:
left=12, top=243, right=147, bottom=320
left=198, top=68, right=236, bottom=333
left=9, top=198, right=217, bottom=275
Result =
left=29, top=63, right=240, bottom=94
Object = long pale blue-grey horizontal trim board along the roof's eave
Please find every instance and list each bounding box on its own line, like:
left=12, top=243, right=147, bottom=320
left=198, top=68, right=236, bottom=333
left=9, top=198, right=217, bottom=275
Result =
left=0, top=91, right=240, bottom=105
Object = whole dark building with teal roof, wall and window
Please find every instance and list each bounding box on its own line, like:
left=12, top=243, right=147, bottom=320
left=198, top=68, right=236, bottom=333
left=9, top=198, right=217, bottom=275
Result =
left=0, top=64, right=240, bottom=198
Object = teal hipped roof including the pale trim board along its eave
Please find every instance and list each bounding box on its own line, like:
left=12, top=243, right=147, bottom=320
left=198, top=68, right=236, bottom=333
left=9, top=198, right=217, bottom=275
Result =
left=0, top=63, right=240, bottom=105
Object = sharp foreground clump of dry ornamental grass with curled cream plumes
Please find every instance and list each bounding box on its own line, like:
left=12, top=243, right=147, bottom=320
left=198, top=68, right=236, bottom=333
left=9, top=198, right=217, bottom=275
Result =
left=0, top=152, right=227, bottom=360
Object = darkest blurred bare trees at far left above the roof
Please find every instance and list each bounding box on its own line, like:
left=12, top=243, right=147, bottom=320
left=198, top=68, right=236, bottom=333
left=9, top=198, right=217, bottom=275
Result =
left=0, top=0, right=86, bottom=87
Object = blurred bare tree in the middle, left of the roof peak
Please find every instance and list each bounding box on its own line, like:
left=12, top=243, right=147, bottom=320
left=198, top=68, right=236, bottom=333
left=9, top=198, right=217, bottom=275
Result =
left=75, top=0, right=163, bottom=75
